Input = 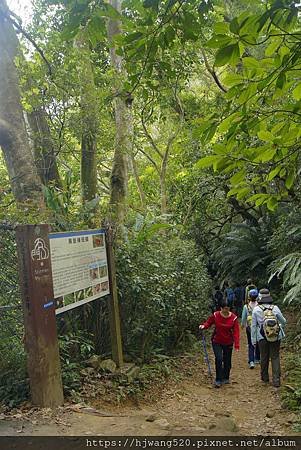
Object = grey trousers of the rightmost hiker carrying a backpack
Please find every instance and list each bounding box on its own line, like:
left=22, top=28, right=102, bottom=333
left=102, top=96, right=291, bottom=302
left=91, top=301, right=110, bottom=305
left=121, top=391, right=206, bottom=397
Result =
left=258, top=339, right=281, bottom=386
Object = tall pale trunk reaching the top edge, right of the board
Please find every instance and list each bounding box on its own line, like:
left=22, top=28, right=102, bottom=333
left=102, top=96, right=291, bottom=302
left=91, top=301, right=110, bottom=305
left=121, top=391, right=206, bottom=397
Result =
left=108, top=0, right=133, bottom=224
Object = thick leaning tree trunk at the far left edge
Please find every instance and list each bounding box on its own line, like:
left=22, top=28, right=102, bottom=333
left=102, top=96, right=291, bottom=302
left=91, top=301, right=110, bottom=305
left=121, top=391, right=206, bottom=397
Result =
left=0, top=0, right=43, bottom=206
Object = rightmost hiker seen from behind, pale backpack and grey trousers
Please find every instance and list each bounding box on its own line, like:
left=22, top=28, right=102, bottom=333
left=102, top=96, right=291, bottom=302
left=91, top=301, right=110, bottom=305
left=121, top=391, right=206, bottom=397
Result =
left=251, top=289, right=286, bottom=388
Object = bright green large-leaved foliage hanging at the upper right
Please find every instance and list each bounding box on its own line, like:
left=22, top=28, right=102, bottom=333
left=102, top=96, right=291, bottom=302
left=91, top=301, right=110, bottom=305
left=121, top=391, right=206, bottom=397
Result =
left=196, top=1, right=300, bottom=211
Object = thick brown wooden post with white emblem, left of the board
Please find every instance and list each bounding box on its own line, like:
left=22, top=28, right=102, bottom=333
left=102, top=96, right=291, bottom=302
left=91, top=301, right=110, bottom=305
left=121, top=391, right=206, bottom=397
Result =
left=16, top=225, right=64, bottom=408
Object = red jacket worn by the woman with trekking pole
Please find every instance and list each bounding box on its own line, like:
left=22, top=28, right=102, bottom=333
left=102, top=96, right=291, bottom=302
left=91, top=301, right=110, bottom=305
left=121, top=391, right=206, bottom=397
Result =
left=203, top=311, right=239, bottom=350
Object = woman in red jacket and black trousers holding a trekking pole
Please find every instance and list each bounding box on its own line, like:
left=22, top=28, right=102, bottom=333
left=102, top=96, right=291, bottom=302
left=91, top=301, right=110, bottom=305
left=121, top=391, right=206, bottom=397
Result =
left=199, top=299, right=239, bottom=388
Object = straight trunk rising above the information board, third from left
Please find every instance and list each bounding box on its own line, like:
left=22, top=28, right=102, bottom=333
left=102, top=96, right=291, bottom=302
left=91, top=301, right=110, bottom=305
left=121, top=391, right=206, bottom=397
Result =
left=76, top=34, right=99, bottom=203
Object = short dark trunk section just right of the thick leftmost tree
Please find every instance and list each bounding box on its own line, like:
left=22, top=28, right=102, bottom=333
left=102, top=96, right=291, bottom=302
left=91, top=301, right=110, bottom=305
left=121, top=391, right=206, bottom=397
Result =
left=27, top=106, right=62, bottom=187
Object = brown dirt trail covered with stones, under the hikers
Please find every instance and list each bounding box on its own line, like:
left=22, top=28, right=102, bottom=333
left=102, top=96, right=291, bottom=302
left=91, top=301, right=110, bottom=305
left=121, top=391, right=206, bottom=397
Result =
left=0, top=332, right=296, bottom=436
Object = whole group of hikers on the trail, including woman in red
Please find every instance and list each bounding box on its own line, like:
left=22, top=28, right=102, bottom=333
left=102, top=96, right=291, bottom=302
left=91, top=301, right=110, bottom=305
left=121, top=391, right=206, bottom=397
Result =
left=199, top=280, right=286, bottom=388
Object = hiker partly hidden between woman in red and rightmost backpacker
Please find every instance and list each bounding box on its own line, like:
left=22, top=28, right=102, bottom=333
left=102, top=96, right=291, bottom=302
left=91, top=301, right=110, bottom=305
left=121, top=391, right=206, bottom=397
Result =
left=241, top=289, right=260, bottom=369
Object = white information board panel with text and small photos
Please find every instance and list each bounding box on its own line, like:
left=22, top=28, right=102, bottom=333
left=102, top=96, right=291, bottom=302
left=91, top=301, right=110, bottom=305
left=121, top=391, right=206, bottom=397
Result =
left=49, top=230, right=110, bottom=314
